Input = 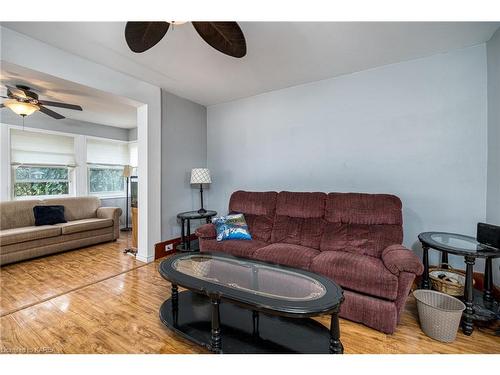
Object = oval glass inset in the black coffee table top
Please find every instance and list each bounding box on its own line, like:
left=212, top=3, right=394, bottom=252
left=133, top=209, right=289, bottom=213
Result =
left=172, top=254, right=326, bottom=301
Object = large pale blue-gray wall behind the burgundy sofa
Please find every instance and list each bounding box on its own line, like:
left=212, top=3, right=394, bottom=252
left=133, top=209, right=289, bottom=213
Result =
left=207, top=45, right=487, bottom=271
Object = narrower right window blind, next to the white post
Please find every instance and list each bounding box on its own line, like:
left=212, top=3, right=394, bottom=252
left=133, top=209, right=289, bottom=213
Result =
left=87, top=138, right=129, bottom=165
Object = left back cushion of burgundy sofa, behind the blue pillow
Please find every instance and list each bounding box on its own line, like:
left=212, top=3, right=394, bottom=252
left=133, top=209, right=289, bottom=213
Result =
left=229, top=190, right=277, bottom=242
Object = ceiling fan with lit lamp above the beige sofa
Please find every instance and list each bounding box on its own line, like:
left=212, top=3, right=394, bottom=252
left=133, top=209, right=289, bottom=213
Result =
left=0, top=85, right=82, bottom=120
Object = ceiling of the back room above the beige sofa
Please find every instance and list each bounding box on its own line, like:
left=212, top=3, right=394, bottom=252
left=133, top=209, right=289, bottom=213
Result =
left=0, top=61, right=139, bottom=129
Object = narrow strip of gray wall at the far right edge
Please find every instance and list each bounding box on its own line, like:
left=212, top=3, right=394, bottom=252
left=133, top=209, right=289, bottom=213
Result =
left=486, top=29, right=500, bottom=225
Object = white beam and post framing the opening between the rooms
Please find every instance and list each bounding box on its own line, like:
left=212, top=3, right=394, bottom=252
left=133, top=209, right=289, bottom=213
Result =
left=0, top=27, right=161, bottom=262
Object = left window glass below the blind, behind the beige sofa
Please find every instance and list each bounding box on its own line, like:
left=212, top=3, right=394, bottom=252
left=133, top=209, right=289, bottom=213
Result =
left=13, top=165, right=70, bottom=198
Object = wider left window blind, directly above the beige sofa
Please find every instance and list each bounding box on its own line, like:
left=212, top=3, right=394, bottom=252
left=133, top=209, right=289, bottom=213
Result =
left=10, top=129, right=75, bottom=166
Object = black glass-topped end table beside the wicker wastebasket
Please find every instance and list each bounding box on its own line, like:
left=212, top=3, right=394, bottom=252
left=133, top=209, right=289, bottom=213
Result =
left=418, top=232, right=500, bottom=335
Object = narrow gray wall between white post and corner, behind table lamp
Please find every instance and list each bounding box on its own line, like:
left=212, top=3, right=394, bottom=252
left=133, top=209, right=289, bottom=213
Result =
left=161, top=90, right=207, bottom=240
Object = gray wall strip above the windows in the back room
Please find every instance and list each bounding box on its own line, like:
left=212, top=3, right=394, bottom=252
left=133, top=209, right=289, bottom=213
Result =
left=0, top=109, right=133, bottom=141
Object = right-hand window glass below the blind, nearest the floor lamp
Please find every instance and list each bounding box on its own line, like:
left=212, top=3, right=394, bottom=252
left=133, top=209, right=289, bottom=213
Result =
left=88, top=165, right=125, bottom=195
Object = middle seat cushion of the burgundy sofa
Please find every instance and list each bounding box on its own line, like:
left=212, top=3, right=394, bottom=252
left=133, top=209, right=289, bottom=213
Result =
left=253, top=243, right=320, bottom=270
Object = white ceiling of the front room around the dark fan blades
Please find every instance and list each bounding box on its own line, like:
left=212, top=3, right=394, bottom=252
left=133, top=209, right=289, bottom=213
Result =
left=3, top=22, right=500, bottom=105
